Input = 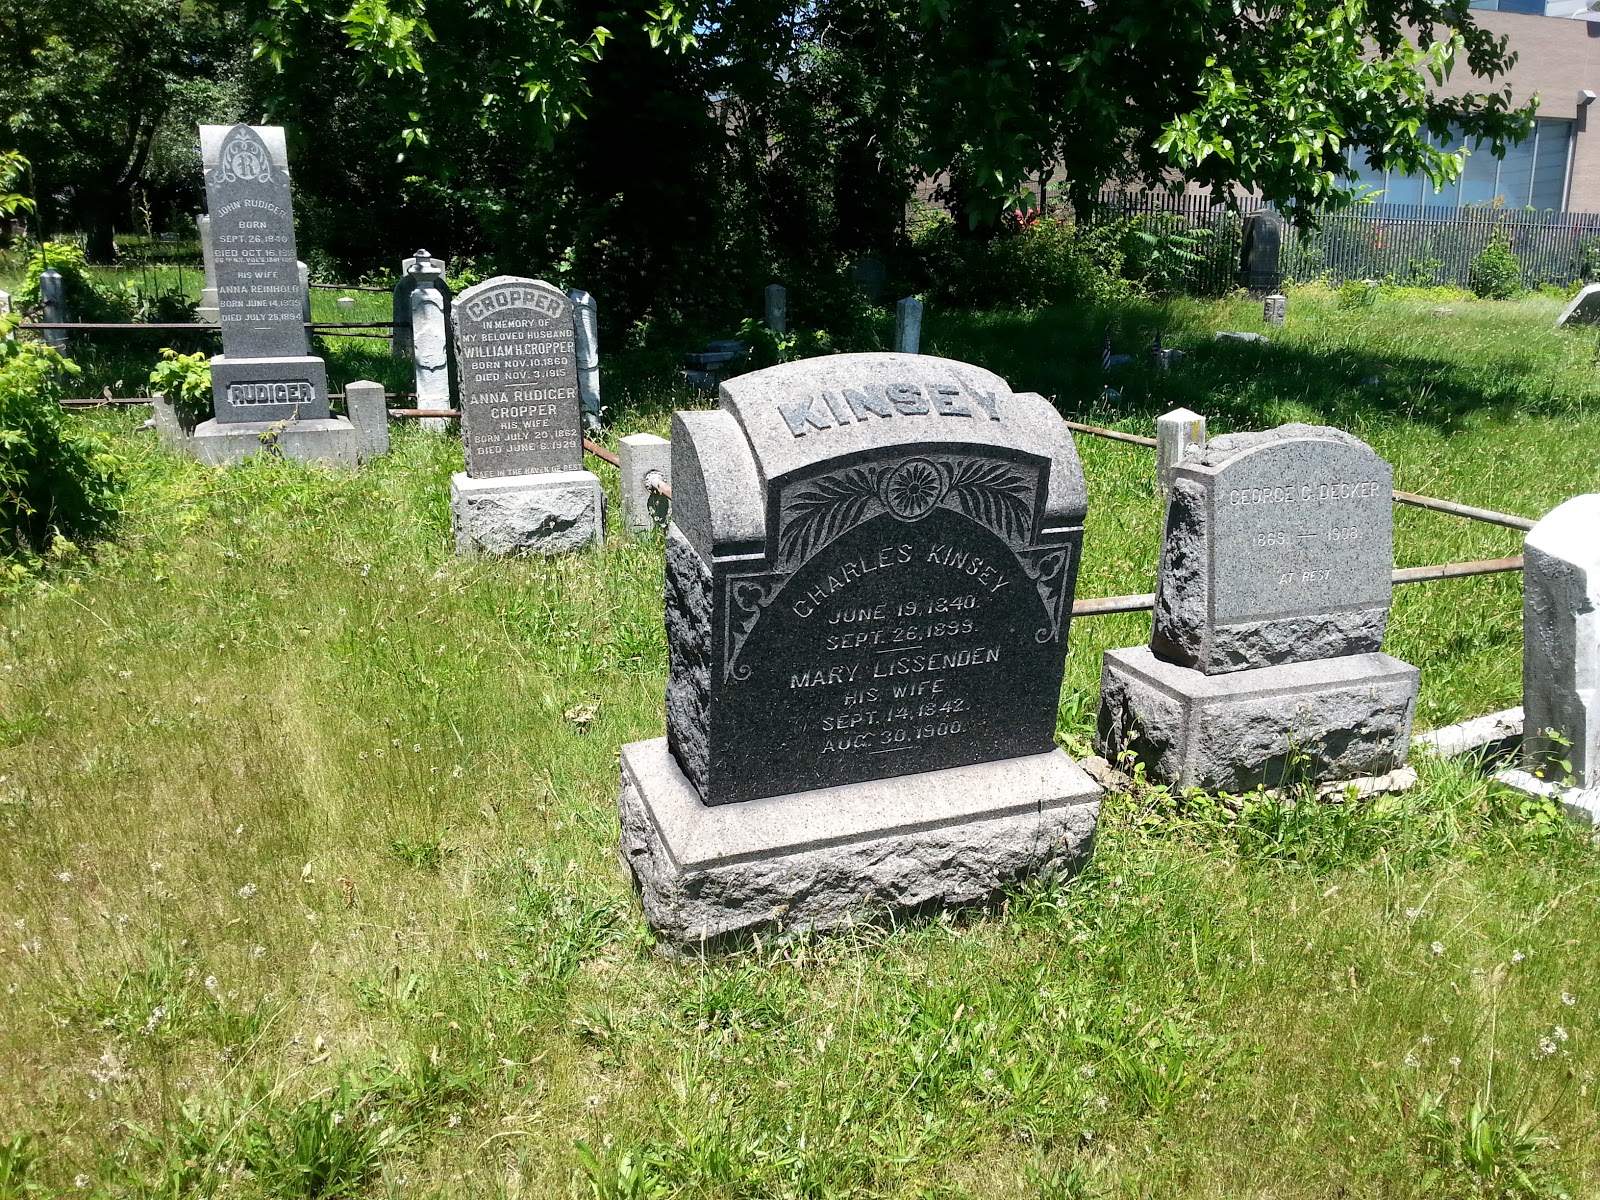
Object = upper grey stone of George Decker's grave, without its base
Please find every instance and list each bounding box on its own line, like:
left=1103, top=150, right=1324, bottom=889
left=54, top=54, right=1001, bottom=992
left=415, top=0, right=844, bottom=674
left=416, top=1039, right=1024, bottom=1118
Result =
left=1150, top=426, right=1394, bottom=675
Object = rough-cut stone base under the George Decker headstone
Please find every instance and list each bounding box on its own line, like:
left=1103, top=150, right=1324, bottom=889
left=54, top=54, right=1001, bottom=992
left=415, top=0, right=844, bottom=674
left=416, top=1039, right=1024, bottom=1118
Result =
left=1098, top=646, right=1419, bottom=792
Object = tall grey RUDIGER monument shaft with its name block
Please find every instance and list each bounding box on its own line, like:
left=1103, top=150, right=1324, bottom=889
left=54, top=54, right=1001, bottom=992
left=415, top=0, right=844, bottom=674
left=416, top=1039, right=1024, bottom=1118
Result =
left=200, top=125, right=328, bottom=422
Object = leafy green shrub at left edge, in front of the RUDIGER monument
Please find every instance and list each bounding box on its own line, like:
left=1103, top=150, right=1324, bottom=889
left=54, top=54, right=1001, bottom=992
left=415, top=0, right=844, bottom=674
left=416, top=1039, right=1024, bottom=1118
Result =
left=0, top=307, right=122, bottom=555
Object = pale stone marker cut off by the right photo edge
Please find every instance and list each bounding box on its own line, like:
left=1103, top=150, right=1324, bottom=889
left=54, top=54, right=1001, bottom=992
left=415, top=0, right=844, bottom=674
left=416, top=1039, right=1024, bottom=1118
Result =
left=1501, top=494, right=1600, bottom=822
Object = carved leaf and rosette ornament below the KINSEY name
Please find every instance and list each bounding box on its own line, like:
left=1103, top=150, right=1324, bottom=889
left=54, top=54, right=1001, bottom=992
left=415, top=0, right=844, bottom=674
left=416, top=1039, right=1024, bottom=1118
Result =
left=778, top=458, right=1035, bottom=563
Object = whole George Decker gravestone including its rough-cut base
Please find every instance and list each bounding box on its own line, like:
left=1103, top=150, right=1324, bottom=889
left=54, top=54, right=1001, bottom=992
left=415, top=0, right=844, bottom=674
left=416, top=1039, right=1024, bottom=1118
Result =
left=1098, top=426, right=1419, bottom=792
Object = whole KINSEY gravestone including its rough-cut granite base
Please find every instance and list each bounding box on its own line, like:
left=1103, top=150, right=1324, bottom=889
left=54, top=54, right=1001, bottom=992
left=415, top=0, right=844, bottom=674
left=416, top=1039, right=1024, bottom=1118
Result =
left=621, top=354, right=1099, bottom=949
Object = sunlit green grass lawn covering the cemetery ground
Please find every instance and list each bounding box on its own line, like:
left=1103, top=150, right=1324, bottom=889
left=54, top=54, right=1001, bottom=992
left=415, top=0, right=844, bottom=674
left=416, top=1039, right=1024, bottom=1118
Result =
left=0, top=290, right=1600, bottom=1200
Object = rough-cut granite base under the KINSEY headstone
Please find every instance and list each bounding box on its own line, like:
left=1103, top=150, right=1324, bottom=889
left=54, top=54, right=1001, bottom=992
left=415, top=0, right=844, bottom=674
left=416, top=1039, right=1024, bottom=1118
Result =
left=621, top=738, right=1101, bottom=954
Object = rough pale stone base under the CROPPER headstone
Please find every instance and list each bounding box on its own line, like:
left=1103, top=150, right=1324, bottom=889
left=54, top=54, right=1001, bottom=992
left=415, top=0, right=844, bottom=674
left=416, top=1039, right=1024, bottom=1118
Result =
left=450, top=470, right=605, bottom=555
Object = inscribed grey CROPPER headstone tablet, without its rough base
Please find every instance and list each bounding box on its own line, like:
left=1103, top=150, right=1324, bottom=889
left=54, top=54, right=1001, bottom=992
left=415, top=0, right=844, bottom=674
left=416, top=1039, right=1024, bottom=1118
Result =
left=451, top=275, right=584, bottom=478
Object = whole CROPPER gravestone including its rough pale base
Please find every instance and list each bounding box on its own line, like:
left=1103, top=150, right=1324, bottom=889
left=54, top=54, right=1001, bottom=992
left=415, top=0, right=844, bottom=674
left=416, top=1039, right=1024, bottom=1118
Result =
left=450, top=275, right=605, bottom=554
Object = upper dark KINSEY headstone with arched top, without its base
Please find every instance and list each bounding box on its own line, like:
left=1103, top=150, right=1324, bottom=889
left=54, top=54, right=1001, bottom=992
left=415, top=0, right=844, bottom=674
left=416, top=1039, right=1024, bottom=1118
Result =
left=667, top=354, right=1085, bottom=805
